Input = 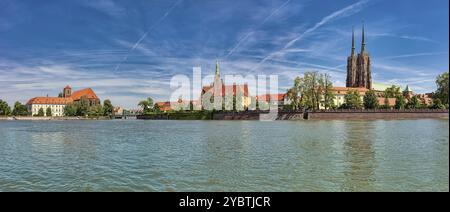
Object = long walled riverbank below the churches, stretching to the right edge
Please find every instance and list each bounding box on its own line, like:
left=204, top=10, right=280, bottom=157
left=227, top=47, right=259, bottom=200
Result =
left=137, top=109, right=449, bottom=121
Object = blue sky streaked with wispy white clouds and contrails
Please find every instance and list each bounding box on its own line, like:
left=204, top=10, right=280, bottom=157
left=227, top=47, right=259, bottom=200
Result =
left=0, top=0, right=449, bottom=108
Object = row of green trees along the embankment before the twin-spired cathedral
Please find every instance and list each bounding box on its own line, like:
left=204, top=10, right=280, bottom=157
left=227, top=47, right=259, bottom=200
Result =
left=286, top=72, right=449, bottom=110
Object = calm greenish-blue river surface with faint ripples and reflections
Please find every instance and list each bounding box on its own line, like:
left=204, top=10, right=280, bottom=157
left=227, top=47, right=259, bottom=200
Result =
left=0, top=119, right=449, bottom=191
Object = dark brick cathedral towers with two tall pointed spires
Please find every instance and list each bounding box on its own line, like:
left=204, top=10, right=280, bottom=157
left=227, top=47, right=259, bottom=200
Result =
left=346, top=25, right=372, bottom=89
